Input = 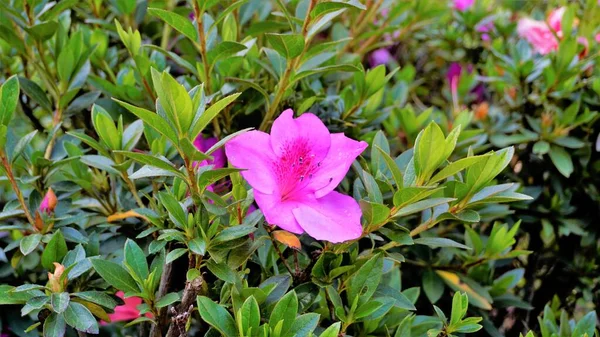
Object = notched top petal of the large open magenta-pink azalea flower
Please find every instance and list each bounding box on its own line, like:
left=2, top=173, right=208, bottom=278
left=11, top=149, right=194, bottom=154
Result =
left=271, top=109, right=330, bottom=161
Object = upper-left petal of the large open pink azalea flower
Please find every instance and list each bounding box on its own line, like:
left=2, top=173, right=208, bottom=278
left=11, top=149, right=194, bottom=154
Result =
left=225, top=131, right=278, bottom=194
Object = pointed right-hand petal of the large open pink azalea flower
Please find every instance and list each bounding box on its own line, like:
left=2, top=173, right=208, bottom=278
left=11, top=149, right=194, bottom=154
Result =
left=307, top=133, right=369, bottom=198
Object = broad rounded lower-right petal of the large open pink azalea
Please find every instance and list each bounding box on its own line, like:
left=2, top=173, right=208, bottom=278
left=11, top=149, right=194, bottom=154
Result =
left=292, top=192, right=362, bottom=243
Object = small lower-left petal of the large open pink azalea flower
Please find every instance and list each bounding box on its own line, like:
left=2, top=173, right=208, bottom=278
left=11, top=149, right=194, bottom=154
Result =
left=254, top=190, right=304, bottom=234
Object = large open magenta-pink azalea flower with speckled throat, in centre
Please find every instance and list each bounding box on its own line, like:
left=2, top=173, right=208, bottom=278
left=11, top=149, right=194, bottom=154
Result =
left=225, top=109, right=368, bottom=243
